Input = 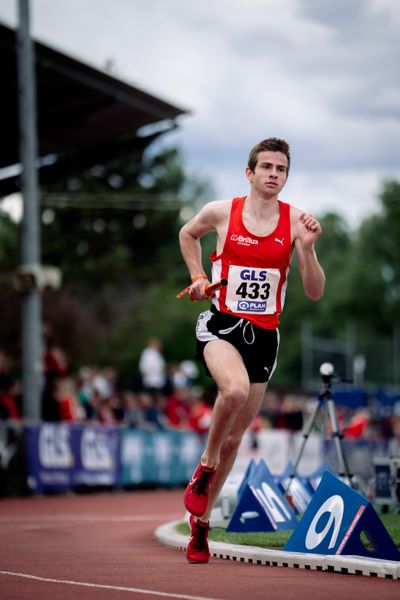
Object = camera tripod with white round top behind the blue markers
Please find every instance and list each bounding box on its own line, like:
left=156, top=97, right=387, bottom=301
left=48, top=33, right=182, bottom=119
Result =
left=285, top=363, right=354, bottom=497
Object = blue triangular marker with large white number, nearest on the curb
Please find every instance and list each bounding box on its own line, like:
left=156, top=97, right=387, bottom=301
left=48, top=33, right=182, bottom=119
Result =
left=284, top=472, right=400, bottom=560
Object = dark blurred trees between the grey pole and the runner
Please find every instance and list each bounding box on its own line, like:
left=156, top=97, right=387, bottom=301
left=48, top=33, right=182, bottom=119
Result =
left=38, top=148, right=210, bottom=372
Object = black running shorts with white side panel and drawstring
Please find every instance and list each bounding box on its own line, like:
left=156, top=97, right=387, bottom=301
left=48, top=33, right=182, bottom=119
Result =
left=196, top=306, right=279, bottom=383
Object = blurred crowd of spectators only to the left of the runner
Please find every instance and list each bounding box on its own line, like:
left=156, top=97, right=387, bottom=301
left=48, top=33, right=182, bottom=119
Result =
left=0, top=337, right=214, bottom=434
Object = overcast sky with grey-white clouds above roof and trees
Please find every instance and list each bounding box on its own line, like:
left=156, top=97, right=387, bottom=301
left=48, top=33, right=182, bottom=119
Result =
left=0, top=0, right=400, bottom=227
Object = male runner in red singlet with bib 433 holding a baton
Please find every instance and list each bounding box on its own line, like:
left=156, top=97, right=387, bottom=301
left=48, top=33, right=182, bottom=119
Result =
left=180, top=138, right=325, bottom=562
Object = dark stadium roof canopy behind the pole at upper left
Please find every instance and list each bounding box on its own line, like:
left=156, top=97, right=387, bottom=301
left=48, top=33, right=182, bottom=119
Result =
left=0, top=24, right=187, bottom=197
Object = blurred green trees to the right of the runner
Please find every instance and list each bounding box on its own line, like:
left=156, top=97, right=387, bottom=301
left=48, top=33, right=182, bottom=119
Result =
left=276, top=181, right=400, bottom=383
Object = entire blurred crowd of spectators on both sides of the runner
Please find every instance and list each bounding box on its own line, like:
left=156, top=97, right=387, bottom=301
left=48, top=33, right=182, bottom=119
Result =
left=0, top=331, right=400, bottom=444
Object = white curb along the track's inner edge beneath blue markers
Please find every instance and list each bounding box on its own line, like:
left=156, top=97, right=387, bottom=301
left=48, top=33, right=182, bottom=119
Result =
left=154, top=521, right=400, bottom=579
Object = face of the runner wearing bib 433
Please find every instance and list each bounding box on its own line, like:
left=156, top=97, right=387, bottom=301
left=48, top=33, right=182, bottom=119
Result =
left=246, top=150, right=288, bottom=195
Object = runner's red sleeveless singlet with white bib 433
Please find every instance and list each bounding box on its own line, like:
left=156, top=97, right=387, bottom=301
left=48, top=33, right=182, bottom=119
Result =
left=210, top=196, right=292, bottom=329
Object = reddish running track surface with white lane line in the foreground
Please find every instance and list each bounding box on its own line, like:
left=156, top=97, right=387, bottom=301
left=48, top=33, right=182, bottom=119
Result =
left=0, top=490, right=400, bottom=600
